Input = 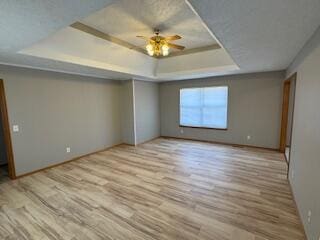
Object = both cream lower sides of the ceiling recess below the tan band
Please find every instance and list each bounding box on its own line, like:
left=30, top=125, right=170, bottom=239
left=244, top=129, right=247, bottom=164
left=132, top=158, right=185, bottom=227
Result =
left=19, top=27, right=238, bottom=81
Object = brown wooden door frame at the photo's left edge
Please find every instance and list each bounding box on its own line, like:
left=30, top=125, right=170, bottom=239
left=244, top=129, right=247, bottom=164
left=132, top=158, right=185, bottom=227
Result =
left=0, top=79, right=16, bottom=179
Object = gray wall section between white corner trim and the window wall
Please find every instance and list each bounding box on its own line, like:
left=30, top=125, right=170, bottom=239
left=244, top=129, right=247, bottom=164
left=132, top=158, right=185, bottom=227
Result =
left=134, top=80, right=160, bottom=144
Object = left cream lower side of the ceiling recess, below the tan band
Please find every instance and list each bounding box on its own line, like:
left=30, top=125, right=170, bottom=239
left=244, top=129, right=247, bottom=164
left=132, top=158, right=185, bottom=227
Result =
left=20, top=27, right=156, bottom=78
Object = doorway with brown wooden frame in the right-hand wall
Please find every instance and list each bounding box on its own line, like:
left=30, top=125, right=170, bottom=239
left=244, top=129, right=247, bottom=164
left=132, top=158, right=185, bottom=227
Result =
left=280, top=73, right=297, bottom=165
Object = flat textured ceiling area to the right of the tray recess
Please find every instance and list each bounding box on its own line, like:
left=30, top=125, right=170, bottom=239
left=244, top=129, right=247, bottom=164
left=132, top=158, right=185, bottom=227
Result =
left=188, top=0, right=320, bottom=72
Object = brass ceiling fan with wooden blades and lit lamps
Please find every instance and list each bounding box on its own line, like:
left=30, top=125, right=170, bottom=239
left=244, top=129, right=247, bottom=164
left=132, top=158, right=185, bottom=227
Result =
left=137, top=29, right=185, bottom=57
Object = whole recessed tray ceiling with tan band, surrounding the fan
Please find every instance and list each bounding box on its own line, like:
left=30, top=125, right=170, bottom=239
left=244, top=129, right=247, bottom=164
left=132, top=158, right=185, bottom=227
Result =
left=19, top=0, right=238, bottom=80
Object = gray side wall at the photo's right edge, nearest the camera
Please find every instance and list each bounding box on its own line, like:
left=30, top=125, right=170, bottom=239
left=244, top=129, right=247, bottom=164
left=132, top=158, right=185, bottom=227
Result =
left=287, top=30, right=320, bottom=240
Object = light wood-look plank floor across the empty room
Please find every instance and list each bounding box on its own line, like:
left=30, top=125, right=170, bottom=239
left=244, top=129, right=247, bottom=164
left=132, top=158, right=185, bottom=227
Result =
left=0, top=138, right=305, bottom=240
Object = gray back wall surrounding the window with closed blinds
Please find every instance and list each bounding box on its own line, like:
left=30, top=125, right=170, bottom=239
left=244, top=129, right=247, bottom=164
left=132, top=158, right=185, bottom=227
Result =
left=160, top=72, right=285, bottom=148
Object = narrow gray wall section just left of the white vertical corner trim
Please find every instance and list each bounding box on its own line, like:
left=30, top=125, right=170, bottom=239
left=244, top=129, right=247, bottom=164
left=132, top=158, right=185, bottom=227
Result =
left=120, top=80, right=136, bottom=145
